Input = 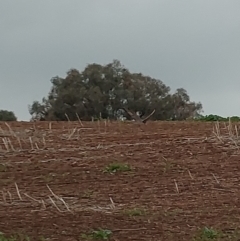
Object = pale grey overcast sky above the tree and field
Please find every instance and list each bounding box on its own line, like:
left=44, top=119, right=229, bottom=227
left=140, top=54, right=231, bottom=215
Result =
left=0, top=0, right=240, bottom=120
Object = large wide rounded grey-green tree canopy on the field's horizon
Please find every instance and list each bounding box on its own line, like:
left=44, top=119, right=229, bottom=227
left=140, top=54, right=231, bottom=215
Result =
left=29, top=60, right=202, bottom=120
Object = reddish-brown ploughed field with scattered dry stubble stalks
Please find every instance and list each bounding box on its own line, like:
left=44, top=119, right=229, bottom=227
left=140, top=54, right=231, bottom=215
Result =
left=0, top=121, right=240, bottom=241
